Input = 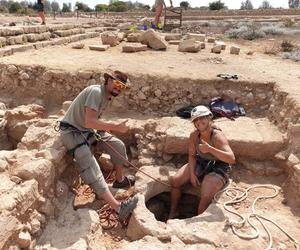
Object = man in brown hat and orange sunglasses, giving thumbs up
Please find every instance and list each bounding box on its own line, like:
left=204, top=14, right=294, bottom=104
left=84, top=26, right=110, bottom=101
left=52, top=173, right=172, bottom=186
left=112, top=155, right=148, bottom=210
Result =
left=60, top=71, right=138, bottom=220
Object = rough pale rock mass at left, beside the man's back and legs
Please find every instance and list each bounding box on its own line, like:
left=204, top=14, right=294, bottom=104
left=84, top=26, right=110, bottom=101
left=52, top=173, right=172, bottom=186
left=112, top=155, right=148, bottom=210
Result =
left=0, top=105, right=69, bottom=249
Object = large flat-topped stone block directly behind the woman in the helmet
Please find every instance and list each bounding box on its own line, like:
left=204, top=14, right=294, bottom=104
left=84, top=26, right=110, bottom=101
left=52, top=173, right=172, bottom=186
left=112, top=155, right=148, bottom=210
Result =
left=157, top=117, right=285, bottom=160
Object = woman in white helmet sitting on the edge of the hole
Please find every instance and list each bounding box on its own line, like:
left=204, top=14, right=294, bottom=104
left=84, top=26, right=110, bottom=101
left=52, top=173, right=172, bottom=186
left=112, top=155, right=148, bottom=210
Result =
left=169, top=106, right=235, bottom=219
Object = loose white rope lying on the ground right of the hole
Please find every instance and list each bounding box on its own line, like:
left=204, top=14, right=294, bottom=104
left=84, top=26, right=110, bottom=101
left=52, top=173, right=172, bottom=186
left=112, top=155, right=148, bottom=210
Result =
left=214, top=185, right=299, bottom=250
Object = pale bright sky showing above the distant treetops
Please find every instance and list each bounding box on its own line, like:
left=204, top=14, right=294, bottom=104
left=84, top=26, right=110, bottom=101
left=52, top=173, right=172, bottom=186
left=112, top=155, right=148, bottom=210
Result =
left=50, top=0, right=288, bottom=9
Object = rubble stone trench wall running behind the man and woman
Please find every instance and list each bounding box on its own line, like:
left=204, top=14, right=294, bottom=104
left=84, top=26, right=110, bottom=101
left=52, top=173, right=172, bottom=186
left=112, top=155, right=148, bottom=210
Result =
left=0, top=64, right=274, bottom=117
